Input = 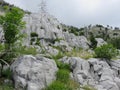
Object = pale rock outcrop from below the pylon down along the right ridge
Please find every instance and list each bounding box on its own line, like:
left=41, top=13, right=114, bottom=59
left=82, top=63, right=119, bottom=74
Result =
left=23, top=13, right=89, bottom=51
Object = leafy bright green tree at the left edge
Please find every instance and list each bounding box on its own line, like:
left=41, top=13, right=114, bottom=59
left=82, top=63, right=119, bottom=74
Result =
left=0, top=7, right=25, bottom=50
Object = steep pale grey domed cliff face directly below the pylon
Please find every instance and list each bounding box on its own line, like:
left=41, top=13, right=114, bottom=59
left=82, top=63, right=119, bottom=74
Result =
left=23, top=13, right=64, bottom=44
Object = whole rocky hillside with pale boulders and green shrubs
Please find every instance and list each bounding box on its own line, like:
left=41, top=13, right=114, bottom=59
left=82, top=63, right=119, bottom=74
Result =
left=0, top=0, right=120, bottom=90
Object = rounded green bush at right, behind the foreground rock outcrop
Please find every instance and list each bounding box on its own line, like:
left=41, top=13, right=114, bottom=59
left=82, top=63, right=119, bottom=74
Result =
left=95, top=44, right=118, bottom=59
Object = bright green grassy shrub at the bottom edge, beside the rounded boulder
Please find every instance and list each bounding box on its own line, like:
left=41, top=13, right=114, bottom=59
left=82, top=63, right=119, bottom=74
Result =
left=45, top=81, right=68, bottom=90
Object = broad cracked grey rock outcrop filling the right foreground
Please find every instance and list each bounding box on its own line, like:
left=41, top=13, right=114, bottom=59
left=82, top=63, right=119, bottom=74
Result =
left=60, top=57, right=120, bottom=90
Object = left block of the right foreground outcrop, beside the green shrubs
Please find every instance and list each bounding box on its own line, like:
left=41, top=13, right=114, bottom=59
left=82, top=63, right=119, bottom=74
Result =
left=62, top=57, right=90, bottom=84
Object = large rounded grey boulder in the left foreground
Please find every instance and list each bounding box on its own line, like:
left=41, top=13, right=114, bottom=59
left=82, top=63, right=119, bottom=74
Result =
left=11, top=55, right=58, bottom=90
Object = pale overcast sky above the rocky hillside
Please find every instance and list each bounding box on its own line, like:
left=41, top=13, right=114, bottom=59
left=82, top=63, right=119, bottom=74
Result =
left=5, top=0, right=120, bottom=27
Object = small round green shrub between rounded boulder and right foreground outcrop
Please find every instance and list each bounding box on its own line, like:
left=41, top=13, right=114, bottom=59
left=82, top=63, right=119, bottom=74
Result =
left=56, top=69, right=70, bottom=83
